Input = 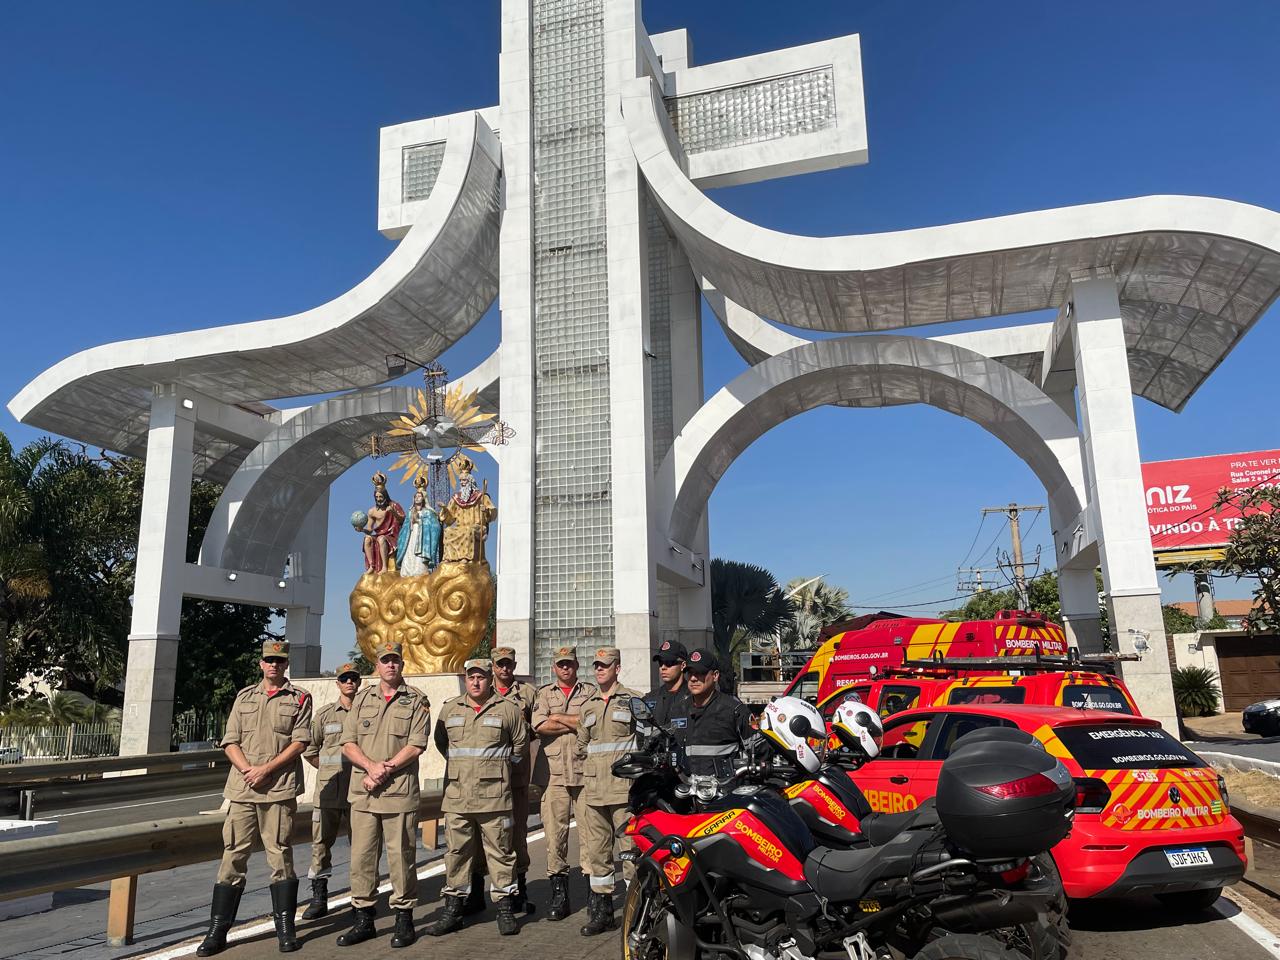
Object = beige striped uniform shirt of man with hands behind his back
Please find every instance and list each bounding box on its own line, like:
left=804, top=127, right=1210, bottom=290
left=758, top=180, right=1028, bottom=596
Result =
left=436, top=694, right=529, bottom=813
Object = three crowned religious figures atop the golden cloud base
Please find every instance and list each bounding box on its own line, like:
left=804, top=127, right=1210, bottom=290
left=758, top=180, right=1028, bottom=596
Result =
left=366, top=454, right=498, bottom=577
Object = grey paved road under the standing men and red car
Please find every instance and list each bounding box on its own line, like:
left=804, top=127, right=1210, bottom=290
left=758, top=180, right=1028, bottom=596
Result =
left=0, top=841, right=1280, bottom=960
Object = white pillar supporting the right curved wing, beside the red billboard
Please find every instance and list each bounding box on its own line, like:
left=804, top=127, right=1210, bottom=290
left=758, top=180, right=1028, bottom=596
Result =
left=1069, top=278, right=1178, bottom=735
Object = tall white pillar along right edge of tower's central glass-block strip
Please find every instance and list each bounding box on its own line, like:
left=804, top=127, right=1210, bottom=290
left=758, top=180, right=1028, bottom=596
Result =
left=604, top=0, right=658, bottom=687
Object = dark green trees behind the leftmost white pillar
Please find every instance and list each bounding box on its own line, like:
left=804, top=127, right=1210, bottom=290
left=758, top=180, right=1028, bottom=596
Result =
left=0, top=434, right=275, bottom=710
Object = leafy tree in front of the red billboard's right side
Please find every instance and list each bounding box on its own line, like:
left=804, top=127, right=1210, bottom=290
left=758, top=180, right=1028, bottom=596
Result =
left=1215, top=486, right=1280, bottom=634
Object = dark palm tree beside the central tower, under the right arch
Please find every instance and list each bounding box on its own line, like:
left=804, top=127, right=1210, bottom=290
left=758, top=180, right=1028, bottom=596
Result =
left=712, top=557, right=794, bottom=691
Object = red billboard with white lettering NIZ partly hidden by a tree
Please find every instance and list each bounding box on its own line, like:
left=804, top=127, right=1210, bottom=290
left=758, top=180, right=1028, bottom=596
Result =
left=1142, top=451, right=1280, bottom=550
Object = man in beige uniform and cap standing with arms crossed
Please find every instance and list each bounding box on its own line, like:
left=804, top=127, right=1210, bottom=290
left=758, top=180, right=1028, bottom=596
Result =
left=534, top=646, right=595, bottom=920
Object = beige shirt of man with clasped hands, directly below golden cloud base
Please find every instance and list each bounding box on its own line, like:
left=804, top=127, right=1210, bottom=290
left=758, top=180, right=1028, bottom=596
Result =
left=342, top=681, right=431, bottom=813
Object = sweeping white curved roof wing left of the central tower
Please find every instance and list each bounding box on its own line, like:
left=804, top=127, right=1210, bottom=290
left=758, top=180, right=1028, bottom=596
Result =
left=9, top=111, right=502, bottom=480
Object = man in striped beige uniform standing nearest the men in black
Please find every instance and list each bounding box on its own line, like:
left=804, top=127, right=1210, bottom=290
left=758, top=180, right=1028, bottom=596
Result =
left=577, top=646, right=640, bottom=937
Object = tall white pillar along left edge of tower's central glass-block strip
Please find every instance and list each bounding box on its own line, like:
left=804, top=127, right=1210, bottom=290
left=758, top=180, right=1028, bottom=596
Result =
left=495, top=0, right=536, bottom=672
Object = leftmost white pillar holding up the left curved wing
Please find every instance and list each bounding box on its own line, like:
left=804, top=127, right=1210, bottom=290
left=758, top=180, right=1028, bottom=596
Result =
left=120, top=384, right=196, bottom=756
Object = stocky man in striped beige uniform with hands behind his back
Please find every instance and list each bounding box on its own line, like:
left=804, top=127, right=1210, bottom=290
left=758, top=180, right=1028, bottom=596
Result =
left=430, top=659, right=529, bottom=937
